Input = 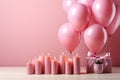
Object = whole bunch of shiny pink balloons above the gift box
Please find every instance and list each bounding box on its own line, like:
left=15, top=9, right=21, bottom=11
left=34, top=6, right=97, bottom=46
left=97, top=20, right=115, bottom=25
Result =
left=58, top=0, right=120, bottom=53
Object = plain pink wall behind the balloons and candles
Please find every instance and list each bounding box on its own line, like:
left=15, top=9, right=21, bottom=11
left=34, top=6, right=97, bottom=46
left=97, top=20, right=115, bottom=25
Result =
left=0, top=0, right=120, bottom=66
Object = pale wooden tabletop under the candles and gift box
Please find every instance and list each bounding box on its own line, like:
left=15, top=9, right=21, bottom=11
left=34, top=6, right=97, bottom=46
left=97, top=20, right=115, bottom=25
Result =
left=0, top=67, right=120, bottom=80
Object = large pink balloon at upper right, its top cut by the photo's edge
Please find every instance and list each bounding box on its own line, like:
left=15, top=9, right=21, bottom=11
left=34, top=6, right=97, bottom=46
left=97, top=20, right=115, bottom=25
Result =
left=92, top=0, right=115, bottom=27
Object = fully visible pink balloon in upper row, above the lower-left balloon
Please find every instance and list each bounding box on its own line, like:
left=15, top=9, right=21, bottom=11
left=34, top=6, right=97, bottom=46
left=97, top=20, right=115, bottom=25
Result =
left=68, top=3, right=88, bottom=32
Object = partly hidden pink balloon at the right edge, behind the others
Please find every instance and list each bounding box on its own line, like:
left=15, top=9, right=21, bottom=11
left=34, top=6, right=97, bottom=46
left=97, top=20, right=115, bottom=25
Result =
left=107, top=6, right=120, bottom=35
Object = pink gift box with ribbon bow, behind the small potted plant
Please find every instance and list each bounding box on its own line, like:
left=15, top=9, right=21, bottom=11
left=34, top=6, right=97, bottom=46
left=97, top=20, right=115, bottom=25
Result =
left=86, top=52, right=112, bottom=73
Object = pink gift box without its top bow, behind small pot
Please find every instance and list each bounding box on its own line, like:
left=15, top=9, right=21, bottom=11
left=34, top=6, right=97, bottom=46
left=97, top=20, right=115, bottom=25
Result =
left=86, top=57, right=112, bottom=73
